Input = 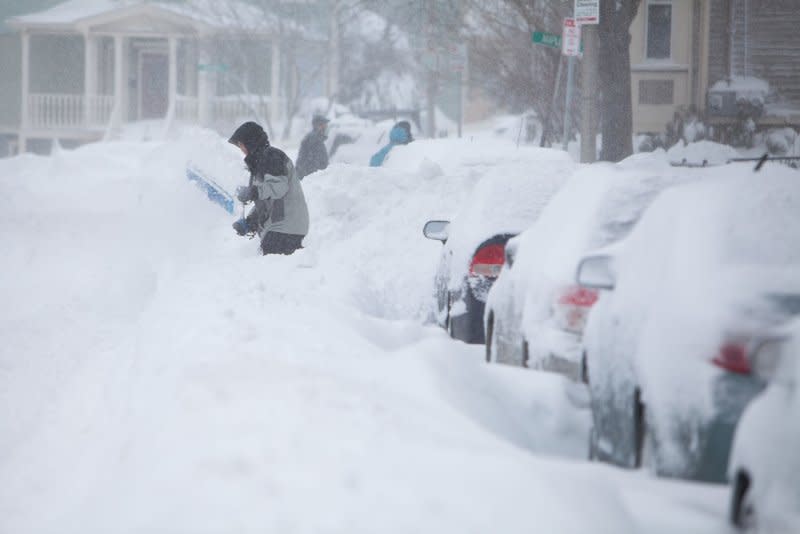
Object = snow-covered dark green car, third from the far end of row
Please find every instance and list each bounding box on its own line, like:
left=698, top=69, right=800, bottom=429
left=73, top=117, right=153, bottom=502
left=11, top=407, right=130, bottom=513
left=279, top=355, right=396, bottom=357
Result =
left=577, top=169, right=800, bottom=482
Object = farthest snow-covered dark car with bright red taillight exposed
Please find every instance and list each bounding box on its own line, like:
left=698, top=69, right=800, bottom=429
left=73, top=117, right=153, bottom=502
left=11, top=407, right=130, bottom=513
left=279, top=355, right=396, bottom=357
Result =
left=423, top=172, right=564, bottom=343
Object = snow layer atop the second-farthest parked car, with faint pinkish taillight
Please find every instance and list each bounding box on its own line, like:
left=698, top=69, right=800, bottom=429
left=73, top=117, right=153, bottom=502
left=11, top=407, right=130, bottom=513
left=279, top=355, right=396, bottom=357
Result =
left=490, top=153, right=689, bottom=342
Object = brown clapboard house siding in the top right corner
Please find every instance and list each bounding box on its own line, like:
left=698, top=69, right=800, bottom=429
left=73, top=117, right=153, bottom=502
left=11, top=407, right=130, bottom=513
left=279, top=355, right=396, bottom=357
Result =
left=709, top=0, right=800, bottom=105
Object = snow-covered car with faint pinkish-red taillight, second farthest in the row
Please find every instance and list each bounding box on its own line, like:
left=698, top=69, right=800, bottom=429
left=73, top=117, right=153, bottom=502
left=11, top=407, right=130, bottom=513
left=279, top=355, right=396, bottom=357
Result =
left=486, top=159, right=688, bottom=380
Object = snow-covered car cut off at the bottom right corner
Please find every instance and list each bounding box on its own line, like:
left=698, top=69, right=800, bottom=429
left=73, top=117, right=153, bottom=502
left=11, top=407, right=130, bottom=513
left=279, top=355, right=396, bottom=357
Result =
left=728, top=321, right=800, bottom=532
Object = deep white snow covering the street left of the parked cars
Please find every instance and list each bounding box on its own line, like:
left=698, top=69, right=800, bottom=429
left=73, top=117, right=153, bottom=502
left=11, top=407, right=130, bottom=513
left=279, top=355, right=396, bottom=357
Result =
left=0, top=132, right=728, bottom=534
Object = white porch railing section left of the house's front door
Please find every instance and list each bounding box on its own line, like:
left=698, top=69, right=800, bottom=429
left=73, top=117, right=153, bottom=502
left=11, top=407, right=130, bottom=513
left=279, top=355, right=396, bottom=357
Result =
left=28, top=93, right=114, bottom=128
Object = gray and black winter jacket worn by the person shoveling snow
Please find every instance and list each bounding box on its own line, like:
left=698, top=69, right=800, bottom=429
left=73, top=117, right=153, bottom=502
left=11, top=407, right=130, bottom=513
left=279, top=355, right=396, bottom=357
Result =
left=245, top=145, right=308, bottom=237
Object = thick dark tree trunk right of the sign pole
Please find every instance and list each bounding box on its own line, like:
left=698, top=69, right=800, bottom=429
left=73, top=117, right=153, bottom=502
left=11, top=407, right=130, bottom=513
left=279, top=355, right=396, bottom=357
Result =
left=598, top=0, right=640, bottom=161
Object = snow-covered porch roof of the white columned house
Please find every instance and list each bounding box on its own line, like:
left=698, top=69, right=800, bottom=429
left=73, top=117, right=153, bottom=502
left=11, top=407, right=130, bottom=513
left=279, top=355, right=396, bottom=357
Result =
left=6, top=0, right=299, bottom=35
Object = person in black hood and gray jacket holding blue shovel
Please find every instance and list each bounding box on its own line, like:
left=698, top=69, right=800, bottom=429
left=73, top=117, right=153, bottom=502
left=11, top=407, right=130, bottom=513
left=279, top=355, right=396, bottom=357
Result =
left=228, top=122, right=308, bottom=255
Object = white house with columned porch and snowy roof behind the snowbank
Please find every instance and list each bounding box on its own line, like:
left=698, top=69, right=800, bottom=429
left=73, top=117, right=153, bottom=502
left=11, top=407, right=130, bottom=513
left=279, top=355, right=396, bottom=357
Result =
left=0, top=0, right=310, bottom=153
